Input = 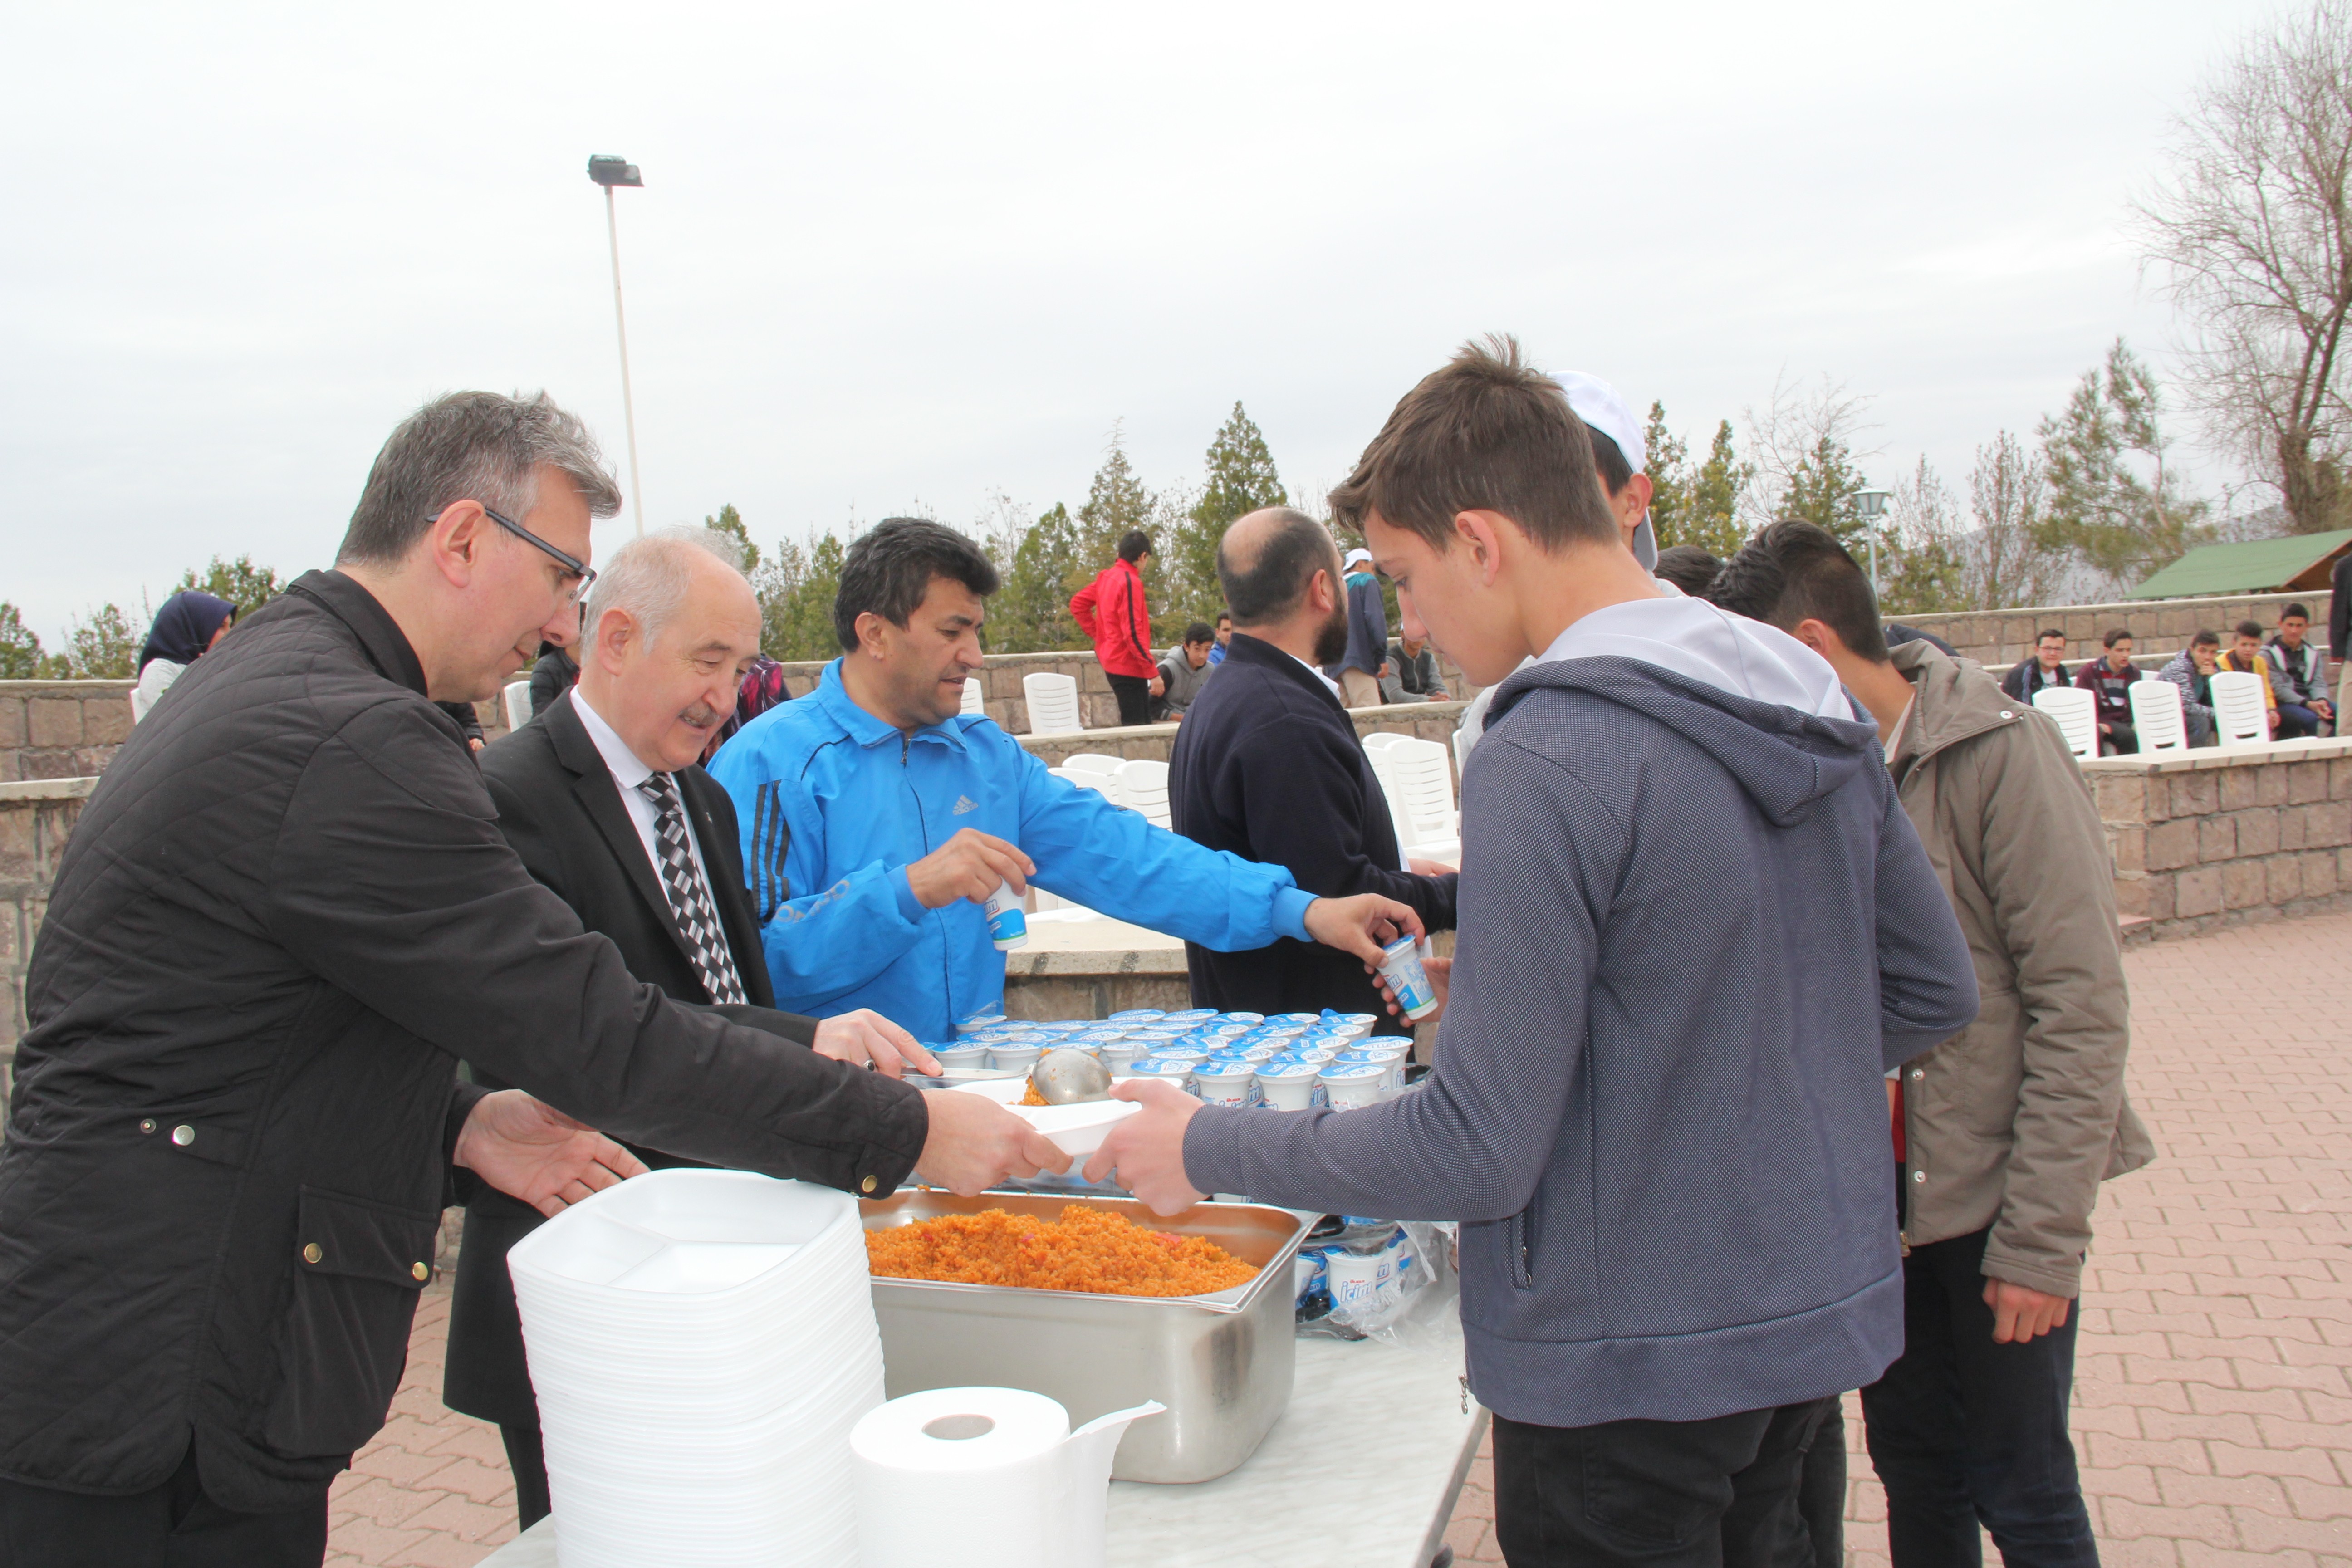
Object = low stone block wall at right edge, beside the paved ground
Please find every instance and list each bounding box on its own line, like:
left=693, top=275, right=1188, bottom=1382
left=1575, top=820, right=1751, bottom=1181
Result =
left=2082, top=738, right=2352, bottom=936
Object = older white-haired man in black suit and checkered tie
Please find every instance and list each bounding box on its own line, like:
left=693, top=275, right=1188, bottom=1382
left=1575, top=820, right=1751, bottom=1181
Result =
left=442, top=529, right=936, bottom=1528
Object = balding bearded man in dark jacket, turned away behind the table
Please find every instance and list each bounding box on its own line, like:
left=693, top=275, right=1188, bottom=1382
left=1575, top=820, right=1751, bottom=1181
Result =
left=1169, top=505, right=1454, bottom=1013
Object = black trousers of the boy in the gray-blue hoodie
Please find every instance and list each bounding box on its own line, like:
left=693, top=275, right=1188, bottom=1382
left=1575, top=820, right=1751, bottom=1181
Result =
left=1494, top=1399, right=1837, bottom=1568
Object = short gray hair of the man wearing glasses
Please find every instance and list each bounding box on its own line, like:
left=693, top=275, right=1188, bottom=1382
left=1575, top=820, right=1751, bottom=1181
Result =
left=334, top=392, right=621, bottom=567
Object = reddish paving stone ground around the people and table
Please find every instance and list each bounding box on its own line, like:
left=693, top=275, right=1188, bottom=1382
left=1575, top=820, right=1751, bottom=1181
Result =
left=327, top=915, right=2352, bottom=1568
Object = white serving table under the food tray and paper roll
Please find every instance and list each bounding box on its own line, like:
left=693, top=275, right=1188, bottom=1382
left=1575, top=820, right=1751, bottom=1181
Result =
left=480, top=1323, right=1486, bottom=1568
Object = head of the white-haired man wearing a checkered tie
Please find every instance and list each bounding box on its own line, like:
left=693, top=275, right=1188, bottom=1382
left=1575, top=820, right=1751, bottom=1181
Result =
left=581, top=529, right=760, bottom=774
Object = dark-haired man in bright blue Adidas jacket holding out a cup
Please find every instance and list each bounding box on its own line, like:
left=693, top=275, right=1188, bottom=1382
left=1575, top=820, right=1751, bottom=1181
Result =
left=710, top=517, right=1421, bottom=1041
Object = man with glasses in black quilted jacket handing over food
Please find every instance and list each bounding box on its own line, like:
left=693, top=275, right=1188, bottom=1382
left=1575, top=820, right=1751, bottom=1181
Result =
left=0, top=392, right=1049, bottom=1568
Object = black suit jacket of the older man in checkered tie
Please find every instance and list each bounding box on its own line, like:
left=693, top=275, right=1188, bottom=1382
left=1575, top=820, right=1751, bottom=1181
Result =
left=442, top=689, right=816, bottom=1427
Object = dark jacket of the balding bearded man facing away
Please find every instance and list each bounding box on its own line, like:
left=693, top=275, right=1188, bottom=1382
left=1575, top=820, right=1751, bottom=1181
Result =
left=1169, top=632, right=1456, bottom=1018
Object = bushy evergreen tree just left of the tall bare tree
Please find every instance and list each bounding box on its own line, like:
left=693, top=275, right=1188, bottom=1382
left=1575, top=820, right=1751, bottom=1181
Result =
left=2037, top=338, right=2213, bottom=590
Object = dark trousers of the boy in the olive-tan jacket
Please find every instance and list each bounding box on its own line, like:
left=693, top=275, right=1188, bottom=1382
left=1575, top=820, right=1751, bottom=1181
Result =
left=1863, top=1230, right=2098, bottom=1568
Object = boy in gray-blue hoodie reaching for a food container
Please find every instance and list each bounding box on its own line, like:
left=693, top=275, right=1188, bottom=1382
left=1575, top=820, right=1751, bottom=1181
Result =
left=1087, top=338, right=1976, bottom=1568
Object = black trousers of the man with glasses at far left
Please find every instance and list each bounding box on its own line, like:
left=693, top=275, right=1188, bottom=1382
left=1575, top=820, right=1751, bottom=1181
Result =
left=0, top=1446, right=327, bottom=1568
